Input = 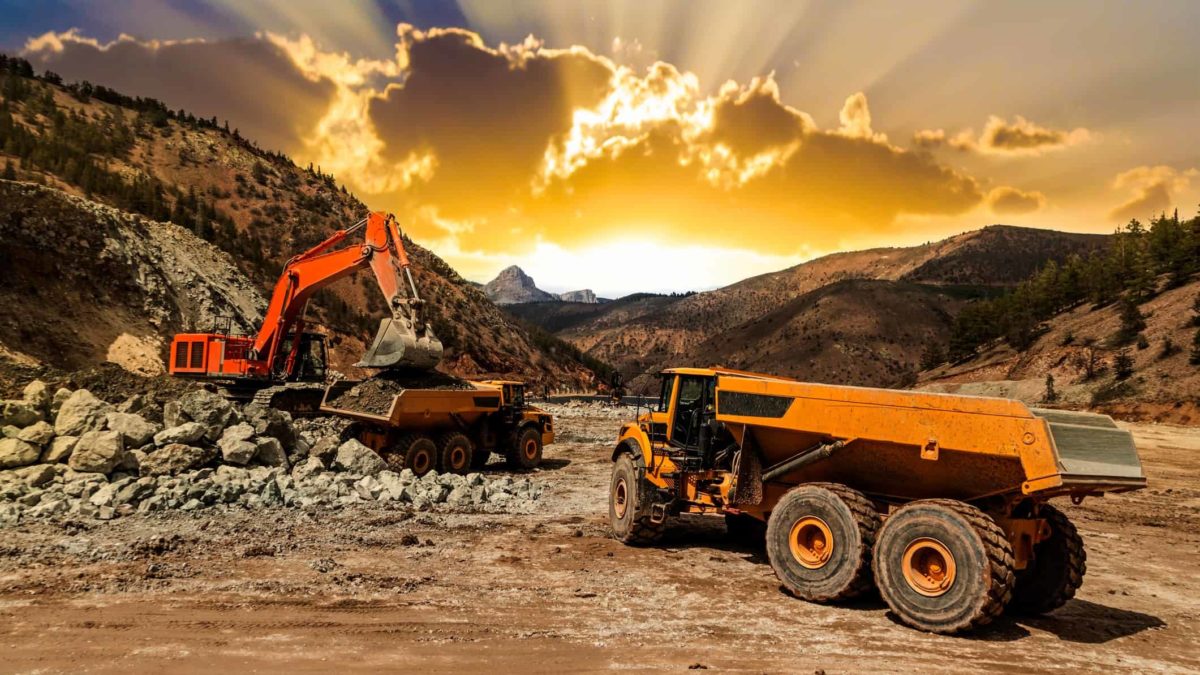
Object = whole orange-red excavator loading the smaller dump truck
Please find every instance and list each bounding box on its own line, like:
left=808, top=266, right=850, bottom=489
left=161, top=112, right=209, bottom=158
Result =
left=168, top=211, right=442, bottom=414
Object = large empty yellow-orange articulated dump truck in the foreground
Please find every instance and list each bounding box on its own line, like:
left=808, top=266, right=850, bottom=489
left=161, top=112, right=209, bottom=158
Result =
left=608, top=368, right=1146, bottom=633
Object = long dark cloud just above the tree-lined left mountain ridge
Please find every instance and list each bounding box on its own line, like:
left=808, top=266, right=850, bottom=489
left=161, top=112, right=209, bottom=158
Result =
left=25, top=32, right=335, bottom=153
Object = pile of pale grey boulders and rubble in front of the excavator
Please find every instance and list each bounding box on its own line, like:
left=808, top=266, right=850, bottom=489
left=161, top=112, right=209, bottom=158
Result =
left=0, top=381, right=541, bottom=525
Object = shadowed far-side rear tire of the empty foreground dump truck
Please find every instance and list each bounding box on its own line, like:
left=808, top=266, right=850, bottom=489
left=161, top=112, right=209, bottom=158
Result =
left=1008, top=504, right=1087, bottom=614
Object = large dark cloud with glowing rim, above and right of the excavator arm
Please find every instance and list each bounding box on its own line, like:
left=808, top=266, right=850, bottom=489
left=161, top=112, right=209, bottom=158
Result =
left=368, top=30, right=612, bottom=217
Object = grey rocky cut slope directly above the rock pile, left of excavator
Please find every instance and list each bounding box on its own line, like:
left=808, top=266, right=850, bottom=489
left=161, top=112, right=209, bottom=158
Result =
left=0, top=180, right=266, bottom=375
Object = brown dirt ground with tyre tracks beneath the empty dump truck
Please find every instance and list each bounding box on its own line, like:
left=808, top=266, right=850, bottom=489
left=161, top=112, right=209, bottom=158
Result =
left=0, top=401, right=1200, bottom=673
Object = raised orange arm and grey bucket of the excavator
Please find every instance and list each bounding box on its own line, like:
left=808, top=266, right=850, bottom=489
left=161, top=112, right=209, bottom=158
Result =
left=251, top=211, right=442, bottom=376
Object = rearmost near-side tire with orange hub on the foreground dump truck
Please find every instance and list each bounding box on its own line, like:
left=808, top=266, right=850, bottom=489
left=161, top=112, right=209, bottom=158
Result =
left=875, top=500, right=1015, bottom=634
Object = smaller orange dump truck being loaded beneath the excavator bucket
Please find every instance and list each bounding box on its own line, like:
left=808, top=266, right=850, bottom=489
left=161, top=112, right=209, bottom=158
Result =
left=320, top=371, right=554, bottom=476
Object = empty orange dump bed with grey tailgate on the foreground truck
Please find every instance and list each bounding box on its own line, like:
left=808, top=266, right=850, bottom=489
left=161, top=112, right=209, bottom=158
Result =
left=716, top=374, right=1146, bottom=500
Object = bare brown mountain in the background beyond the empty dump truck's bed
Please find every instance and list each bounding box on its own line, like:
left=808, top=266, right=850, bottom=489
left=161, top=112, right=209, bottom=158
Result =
left=520, top=225, right=1106, bottom=384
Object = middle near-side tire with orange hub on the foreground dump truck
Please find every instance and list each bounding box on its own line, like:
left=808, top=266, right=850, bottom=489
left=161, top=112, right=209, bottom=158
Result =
left=767, top=483, right=880, bottom=603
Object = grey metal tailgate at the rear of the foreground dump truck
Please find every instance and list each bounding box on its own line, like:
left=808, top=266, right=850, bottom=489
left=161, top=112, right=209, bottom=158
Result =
left=1031, top=408, right=1146, bottom=492
